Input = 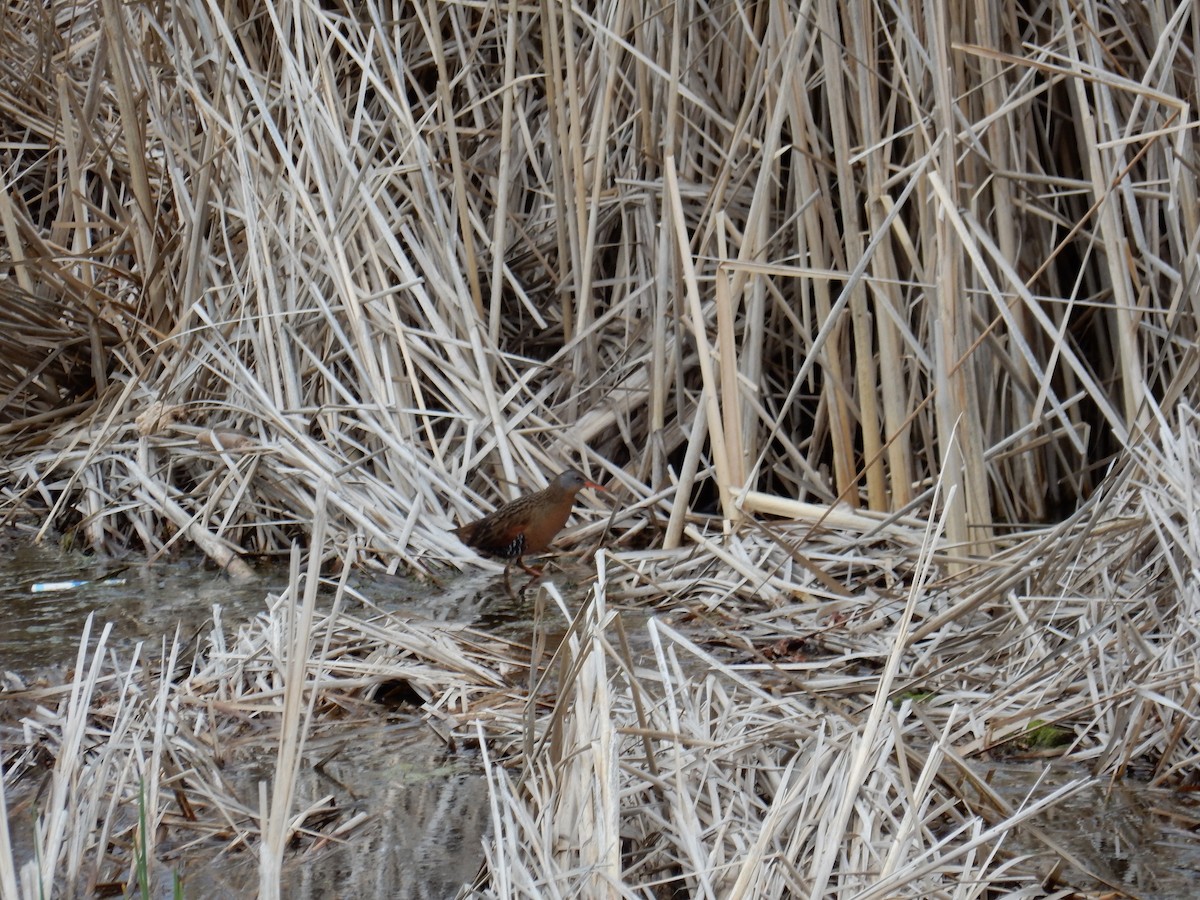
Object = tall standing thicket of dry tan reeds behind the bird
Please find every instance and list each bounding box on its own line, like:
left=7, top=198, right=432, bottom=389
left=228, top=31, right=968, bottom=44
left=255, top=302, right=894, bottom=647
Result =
left=0, top=0, right=1200, bottom=585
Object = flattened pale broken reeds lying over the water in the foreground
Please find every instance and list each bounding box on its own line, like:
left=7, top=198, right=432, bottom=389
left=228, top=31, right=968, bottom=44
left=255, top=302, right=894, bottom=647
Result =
left=0, top=413, right=1200, bottom=898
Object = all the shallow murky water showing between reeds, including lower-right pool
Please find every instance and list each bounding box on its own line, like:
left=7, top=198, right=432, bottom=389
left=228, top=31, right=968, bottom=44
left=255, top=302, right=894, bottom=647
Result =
left=0, top=542, right=1200, bottom=900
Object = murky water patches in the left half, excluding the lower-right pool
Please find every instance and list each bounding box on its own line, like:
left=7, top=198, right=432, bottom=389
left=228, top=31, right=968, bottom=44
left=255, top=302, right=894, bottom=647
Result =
left=0, top=541, right=497, bottom=899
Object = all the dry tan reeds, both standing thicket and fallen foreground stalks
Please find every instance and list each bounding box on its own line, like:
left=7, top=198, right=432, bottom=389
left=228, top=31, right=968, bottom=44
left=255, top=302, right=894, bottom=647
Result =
left=0, top=0, right=1200, bottom=896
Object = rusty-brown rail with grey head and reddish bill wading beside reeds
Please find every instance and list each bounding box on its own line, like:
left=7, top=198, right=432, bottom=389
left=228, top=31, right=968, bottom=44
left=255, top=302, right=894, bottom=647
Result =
left=454, top=469, right=605, bottom=576
